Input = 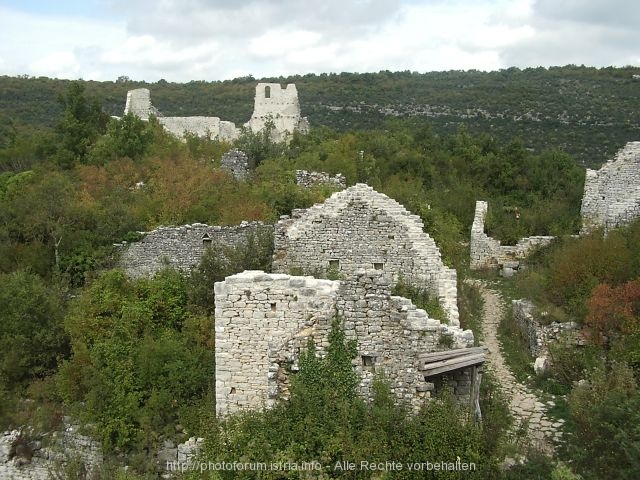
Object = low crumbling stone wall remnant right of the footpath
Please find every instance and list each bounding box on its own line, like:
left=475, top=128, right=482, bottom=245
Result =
left=511, top=299, right=586, bottom=375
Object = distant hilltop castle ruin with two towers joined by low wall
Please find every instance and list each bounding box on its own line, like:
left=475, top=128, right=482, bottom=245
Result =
left=124, top=83, right=309, bottom=141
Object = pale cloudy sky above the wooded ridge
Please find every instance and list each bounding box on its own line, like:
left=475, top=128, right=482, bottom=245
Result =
left=0, top=0, right=640, bottom=82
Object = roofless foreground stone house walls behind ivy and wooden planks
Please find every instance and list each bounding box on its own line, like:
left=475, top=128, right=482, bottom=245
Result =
left=215, top=270, right=475, bottom=416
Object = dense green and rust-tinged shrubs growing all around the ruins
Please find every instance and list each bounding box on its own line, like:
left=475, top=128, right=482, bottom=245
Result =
left=0, top=77, right=640, bottom=479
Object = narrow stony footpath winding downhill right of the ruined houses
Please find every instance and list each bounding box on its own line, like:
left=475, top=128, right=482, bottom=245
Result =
left=473, top=280, right=562, bottom=454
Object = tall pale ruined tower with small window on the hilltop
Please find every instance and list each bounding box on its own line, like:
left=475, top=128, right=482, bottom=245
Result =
left=245, top=83, right=309, bottom=141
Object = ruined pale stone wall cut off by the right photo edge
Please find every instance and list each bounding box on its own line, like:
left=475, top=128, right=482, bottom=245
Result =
left=581, top=142, right=640, bottom=233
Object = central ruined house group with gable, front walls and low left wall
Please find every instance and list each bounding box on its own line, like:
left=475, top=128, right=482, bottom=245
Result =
left=115, top=184, right=484, bottom=415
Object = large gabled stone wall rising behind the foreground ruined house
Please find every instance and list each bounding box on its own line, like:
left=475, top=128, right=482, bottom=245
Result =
left=273, top=184, right=459, bottom=325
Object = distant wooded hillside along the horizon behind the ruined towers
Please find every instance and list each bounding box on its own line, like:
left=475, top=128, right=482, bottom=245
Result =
left=0, top=66, right=640, bottom=166
